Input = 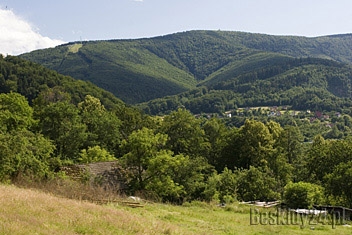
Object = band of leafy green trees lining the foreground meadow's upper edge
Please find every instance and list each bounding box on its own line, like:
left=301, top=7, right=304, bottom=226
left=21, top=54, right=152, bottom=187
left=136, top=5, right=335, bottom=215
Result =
left=0, top=93, right=352, bottom=207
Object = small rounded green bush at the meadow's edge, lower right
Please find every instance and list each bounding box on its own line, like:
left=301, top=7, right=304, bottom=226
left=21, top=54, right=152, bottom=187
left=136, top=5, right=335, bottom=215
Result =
left=284, top=181, right=323, bottom=209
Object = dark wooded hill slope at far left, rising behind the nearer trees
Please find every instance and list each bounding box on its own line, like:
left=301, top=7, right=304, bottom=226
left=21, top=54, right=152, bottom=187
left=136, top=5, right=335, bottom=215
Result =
left=0, top=56, right=124, bottom=108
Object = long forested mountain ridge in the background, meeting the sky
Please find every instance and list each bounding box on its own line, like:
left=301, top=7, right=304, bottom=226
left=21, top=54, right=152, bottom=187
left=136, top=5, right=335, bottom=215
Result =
left=21, top=30, right=352, bottom=110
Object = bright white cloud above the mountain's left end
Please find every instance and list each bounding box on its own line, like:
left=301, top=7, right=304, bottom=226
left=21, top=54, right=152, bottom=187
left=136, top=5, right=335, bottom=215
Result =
left=0, top=9, right=64, bottom=55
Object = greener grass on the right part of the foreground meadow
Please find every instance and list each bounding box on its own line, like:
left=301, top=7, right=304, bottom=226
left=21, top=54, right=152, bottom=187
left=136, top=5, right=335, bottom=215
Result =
left=117, top=203, right=352, bottom=234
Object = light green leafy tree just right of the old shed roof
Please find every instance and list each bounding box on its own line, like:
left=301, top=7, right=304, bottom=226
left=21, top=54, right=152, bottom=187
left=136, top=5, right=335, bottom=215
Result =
left=120, top=127, right=213, bottom=202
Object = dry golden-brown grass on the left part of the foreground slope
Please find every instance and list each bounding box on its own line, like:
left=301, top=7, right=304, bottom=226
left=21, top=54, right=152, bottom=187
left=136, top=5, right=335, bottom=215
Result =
left=0, top=185, right=189, bottom=234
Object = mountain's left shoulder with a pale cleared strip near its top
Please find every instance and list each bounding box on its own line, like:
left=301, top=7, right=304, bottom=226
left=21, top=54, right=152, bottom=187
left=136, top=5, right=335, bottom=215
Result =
left=23, top=41, right=196, bottom=103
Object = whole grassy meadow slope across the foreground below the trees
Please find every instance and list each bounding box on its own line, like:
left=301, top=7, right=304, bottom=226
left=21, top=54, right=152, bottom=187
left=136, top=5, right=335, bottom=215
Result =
left=0, top=185, right=352, bottom=235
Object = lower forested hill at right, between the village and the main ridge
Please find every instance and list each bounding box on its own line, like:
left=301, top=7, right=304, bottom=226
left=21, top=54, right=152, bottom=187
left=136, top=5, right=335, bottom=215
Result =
left=139, top=56, right=352, bottom=114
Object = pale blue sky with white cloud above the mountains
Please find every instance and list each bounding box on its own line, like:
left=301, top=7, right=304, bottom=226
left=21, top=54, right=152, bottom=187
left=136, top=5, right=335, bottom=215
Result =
left=0, top=0, right=352, bottom=55
